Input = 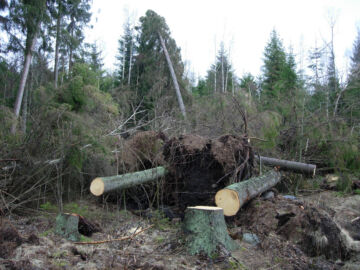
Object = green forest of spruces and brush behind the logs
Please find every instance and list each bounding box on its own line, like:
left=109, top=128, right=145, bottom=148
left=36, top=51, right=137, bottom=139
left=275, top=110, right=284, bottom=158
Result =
left=0, top=0, right=360, bottom=215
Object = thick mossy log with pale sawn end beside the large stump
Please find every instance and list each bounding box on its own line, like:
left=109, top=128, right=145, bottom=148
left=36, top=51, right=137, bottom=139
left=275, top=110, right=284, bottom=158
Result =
left=215, top=170, right=280, bottom=216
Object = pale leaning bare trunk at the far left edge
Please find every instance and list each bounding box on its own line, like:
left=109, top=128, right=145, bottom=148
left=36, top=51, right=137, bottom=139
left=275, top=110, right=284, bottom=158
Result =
left=11, top=35, right=36, bottom=134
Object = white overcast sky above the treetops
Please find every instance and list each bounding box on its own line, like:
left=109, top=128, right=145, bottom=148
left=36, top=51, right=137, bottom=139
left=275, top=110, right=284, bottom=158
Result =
left=86, top=0, right=360, bottom=80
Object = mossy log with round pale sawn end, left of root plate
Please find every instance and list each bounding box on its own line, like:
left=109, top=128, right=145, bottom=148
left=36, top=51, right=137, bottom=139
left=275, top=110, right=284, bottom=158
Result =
left=90, top=166, right=167, bottom=196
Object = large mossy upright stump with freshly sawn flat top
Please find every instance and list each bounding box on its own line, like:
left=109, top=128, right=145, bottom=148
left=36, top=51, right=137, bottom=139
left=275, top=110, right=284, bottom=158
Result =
left=183, top=206, right=237, bottom=256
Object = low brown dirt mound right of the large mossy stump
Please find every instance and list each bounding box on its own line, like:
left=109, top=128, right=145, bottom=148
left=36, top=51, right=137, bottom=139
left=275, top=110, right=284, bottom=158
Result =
left=236, top=197, right=348, bottom=260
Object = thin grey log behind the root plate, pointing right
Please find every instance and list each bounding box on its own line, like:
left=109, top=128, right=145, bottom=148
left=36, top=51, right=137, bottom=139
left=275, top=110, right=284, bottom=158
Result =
left=255, top=156, right=316, bottom=176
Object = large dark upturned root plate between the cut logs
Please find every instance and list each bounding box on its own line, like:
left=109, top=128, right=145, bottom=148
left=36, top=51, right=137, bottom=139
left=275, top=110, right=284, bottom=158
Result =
left=164, top=135, right=254, bottom=209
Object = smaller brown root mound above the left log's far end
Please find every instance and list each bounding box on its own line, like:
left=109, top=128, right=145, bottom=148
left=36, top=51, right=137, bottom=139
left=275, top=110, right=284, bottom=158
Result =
left=121, top=131, right=166, bottom=171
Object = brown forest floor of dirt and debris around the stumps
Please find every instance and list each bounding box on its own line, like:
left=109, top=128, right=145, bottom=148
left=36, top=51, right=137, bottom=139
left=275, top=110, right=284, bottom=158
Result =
left=0, top=191, right=360, bottom=270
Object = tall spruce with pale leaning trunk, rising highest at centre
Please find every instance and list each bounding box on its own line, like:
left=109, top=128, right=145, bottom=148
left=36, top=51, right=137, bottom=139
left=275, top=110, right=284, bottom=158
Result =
left=133, top=10, right=185, bottom=117
